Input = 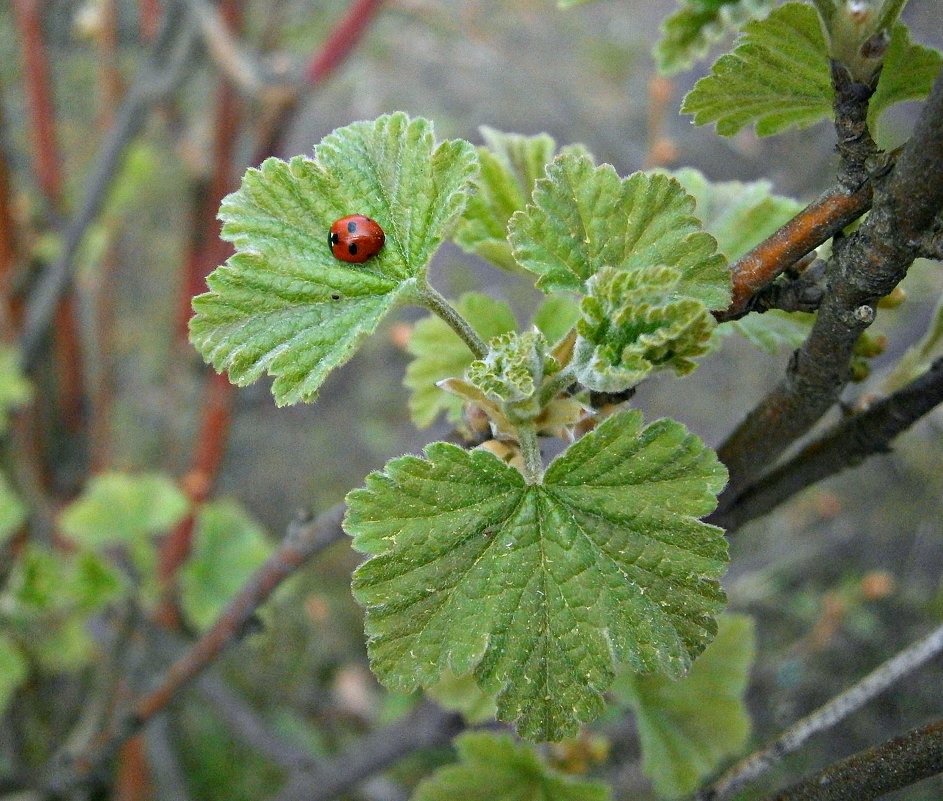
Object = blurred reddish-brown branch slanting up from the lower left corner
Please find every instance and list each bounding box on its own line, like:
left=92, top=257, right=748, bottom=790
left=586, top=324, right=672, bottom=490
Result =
left=45, top=504, right=344, bottom=793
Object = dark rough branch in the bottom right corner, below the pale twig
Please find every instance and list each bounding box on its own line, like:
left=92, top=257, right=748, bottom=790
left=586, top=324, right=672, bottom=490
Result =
left=770, top=720, right=943, bottom=801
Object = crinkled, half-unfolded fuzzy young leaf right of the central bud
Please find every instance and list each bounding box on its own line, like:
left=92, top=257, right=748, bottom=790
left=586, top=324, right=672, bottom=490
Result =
left=573, top=267, right=716, bottom=392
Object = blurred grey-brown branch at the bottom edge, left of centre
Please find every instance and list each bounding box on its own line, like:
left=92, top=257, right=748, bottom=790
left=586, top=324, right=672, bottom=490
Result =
left=273, top=701, right=464, bottom=801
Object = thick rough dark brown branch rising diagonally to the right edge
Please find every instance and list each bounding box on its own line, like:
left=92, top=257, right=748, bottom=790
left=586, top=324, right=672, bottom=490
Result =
left=718, top=69, right=943, bottom=506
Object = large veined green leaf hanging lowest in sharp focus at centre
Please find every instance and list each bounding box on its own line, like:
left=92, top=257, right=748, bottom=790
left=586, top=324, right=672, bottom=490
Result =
left=345, top=411, right=727, bottom=739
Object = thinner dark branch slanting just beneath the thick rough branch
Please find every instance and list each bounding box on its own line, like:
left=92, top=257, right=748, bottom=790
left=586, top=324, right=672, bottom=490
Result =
left=708, top=358, right=943, bottom=531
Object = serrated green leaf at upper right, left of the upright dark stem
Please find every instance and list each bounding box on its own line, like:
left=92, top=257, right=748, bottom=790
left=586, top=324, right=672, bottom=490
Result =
left=681, top=3, right=833, bottom=136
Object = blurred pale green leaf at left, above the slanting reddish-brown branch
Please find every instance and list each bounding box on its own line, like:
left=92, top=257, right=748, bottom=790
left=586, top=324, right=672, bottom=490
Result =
left=59, top=473, right=189, bottom=549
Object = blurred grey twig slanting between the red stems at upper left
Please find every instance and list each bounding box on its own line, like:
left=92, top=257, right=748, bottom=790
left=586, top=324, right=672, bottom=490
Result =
left=20, top=6, right=194, bottom=367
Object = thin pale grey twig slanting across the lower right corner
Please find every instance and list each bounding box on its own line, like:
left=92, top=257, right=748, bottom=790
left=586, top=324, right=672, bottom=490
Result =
left=695, top=626, right=943, bottom=801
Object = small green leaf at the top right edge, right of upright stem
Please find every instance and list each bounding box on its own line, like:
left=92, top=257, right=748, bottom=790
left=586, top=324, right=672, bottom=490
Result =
left=868, top=25, right=943, bottom=132
